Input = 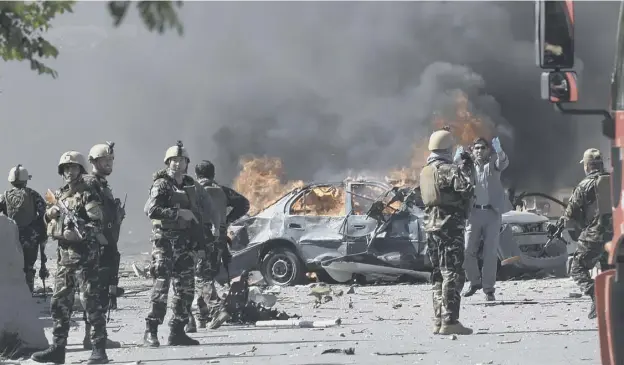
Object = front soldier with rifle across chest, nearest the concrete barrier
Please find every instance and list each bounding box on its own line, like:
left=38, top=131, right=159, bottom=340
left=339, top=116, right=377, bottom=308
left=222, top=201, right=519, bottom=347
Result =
left=32, top=151, right=108, bottom=364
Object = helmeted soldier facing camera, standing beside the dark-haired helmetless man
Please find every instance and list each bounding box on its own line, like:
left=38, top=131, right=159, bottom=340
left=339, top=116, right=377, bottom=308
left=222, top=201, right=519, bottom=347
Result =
left=144, top=142, right=204, bottom=347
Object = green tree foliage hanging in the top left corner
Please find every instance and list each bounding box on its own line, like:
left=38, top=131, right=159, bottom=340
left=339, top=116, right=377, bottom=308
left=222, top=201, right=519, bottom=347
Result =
left=0, top=1, right=184, bottom=78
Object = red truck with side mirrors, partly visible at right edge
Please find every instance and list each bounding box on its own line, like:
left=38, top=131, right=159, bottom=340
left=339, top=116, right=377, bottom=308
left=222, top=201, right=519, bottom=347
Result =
left=535, top=0, right=624, bottom=365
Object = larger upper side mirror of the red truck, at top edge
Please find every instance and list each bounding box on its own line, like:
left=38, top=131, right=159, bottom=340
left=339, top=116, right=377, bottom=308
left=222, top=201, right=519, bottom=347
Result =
left=535, top=0, right=574, bottom=70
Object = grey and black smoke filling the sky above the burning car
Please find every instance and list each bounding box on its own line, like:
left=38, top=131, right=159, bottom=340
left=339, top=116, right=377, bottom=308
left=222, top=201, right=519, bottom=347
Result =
left=0, top=2, right=618, bottom=253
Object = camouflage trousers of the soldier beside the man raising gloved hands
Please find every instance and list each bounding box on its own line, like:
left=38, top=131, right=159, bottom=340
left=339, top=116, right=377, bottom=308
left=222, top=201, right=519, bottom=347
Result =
left=427, top=229, right=466, bottom=324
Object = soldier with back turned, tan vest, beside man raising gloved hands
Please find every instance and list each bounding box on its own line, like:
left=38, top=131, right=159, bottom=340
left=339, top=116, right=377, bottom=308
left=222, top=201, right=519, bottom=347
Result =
left=420, top=130, right=474, bottom=335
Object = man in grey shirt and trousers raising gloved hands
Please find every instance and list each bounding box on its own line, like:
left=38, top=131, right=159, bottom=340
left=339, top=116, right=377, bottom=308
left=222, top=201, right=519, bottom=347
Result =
left=455, top=137, right=509, bottom=301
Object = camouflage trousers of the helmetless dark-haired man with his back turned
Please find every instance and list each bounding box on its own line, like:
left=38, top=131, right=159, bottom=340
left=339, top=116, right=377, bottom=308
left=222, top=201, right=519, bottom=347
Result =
left=195, top=242, right=222, bottom=320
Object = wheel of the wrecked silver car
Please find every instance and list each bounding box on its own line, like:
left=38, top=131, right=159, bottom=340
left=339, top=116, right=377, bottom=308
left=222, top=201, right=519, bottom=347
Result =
left=260, top=247, right=306, bottom=286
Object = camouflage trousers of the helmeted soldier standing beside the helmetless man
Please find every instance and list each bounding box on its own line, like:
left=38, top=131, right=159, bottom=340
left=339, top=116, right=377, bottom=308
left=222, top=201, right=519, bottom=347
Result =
left=146, top=230, right=195, bottom=326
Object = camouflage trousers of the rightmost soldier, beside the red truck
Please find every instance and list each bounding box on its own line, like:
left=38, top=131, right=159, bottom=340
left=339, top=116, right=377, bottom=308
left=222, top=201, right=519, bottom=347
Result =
left=570, top=241, right=609, bottom=296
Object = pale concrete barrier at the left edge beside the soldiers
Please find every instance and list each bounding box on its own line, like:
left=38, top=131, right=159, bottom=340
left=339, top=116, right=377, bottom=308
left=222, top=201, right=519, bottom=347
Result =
left=0, top=215, right=48, bottom=349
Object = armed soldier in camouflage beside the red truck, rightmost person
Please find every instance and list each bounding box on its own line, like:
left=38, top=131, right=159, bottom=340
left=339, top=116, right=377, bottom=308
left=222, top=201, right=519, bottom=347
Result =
left=549, top=148, right=613, bottom=319
